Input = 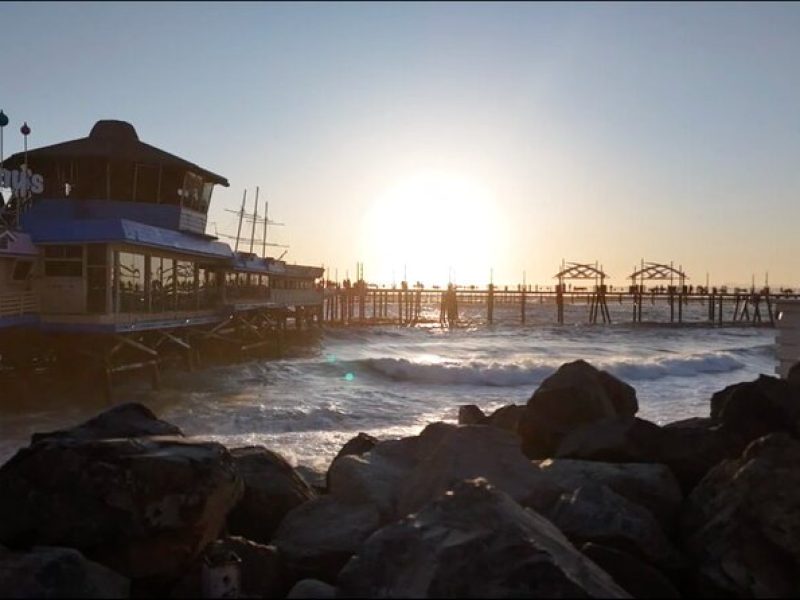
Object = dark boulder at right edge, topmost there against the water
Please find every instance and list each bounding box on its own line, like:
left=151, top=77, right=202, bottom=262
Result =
left=711, top=375, right=800, bottom=444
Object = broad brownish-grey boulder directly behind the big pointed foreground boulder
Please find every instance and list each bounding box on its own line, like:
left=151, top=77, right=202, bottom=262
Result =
left=397, top=425, right=562, bottom=517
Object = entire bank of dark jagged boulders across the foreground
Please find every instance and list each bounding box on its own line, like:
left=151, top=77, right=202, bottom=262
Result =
left=0, top=361, right=800, bottom=598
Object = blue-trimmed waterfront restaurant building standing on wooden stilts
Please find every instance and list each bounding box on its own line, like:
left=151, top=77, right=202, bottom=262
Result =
left=0, top=121, right=323, bottom=389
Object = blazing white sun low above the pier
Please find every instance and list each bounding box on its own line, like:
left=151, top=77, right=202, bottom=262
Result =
left=362, top=172, right=503, bottom=286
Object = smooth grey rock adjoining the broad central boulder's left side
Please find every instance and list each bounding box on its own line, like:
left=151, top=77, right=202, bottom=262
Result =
left=328, top=423, right=456, bottom=522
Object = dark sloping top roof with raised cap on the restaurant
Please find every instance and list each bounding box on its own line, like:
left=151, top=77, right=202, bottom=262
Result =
left=4, top=120, right=229, bottom=187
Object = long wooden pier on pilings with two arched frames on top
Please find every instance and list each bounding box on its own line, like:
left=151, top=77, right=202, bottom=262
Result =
left=322, top=261, right=800, bottom=327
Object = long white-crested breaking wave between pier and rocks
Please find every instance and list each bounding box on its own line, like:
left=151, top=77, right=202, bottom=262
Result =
left=356, top=352, right=745, bottom=387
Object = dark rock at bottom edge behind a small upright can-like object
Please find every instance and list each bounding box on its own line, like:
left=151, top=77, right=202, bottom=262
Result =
left=170, top=537, right=286, bottom=598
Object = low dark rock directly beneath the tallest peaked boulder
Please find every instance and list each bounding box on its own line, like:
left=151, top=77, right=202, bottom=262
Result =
left=554, top=417, right=664, bottom=462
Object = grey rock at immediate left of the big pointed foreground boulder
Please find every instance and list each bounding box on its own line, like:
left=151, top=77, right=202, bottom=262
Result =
left=274, top=496, right=380, bottom=583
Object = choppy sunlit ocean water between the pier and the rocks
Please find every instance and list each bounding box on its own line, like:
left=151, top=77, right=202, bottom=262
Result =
left=0, top=303, right=775, bottom=469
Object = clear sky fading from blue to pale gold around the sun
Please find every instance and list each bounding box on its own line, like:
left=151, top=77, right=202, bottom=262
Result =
left=0, top=2, right=800, bottom=286
